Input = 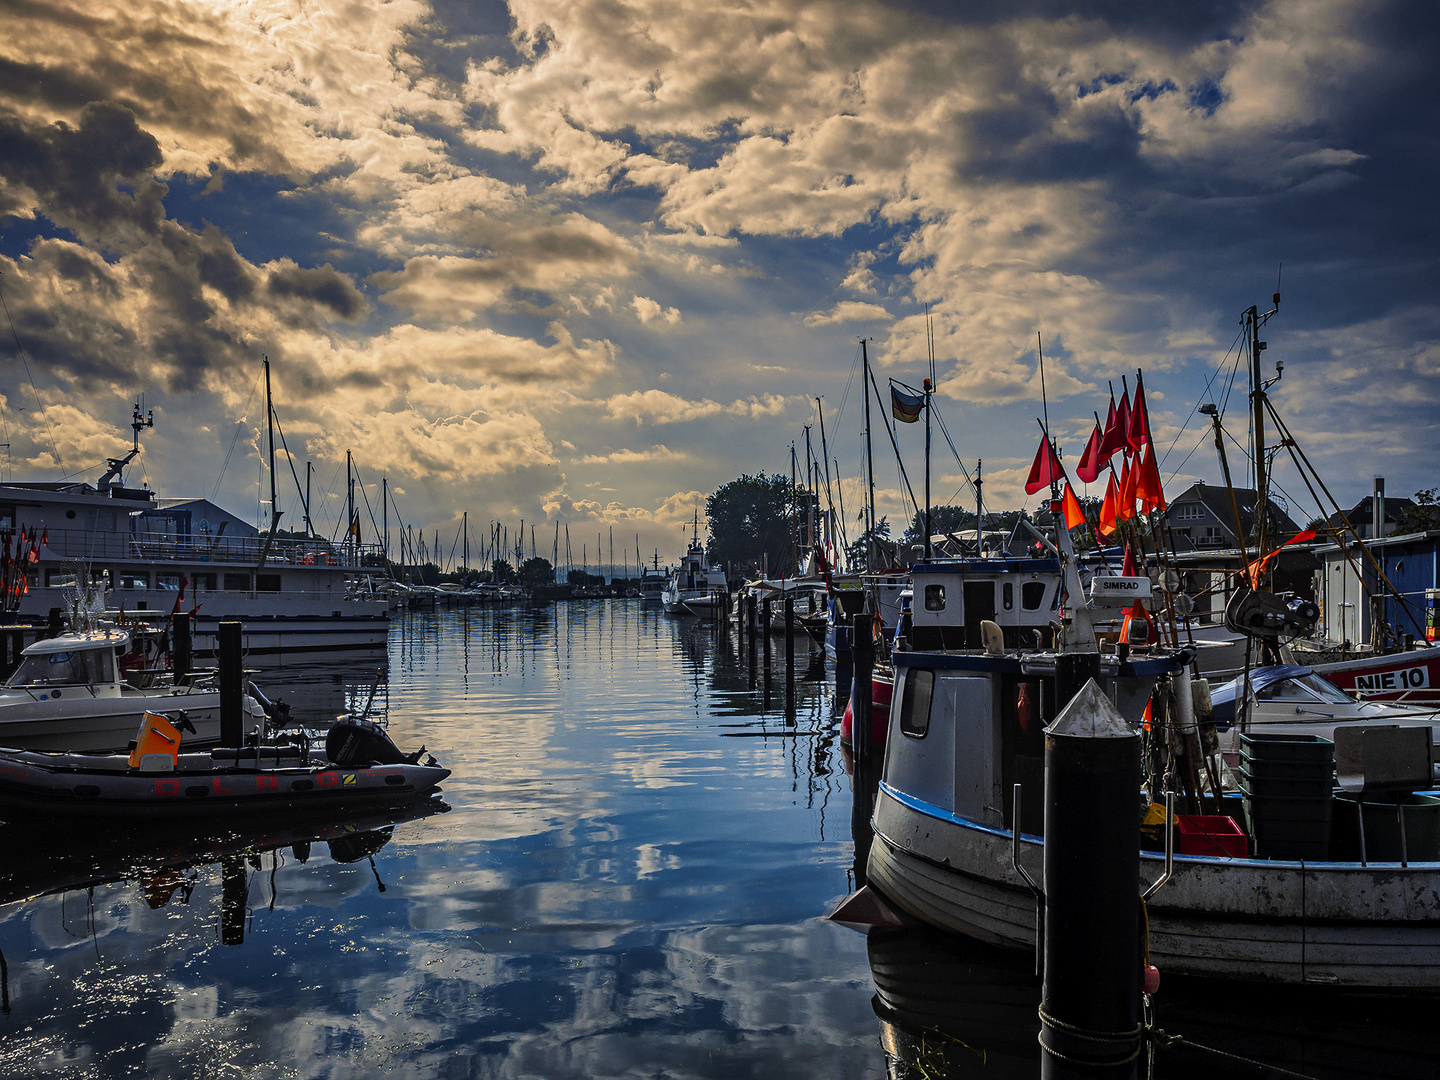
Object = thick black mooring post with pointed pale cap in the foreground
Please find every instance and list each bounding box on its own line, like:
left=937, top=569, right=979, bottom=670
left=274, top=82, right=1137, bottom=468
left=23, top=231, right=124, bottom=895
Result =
left=1040, top=679, right=1142, bottom=1080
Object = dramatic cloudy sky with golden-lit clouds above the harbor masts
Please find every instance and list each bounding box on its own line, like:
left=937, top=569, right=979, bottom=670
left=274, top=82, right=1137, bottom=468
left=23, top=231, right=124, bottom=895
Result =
left=0, top=0, right=1440, bottom=562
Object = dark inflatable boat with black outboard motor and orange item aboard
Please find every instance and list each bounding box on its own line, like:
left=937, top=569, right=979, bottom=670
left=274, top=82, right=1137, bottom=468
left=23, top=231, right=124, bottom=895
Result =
left=0, top=713, right=449, bottom=824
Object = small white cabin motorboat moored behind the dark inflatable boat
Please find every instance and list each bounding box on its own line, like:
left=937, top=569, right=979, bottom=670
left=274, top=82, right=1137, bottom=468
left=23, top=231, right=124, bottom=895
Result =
left=0, top=628, right=265, bottom=753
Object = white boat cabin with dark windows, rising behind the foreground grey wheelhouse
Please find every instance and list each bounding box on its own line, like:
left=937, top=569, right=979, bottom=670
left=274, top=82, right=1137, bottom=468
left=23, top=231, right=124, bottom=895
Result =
left=901, top=559, right=1061, bottom=651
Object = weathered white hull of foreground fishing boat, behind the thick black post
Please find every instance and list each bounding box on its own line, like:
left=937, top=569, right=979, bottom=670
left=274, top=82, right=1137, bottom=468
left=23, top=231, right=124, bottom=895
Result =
left=867, top=785, right=1440, bottom=989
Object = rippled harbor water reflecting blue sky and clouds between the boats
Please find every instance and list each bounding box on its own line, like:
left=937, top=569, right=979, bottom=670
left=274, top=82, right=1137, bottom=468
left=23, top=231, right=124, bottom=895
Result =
left=0, top=600, right=1440, bottom=1077
